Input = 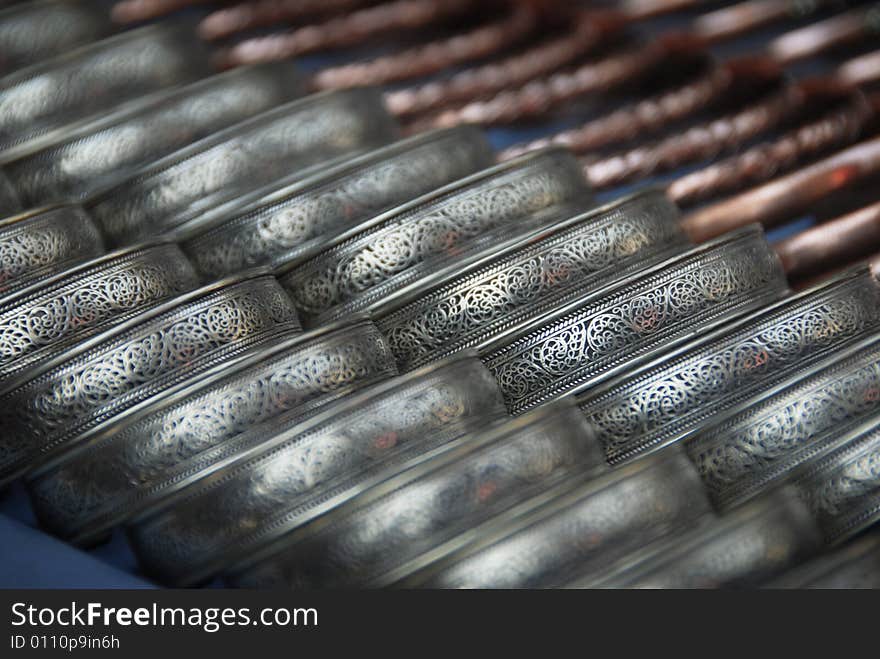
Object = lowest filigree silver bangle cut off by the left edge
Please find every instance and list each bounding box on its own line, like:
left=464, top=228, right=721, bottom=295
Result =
left=0, top=275, right=299, bottom=481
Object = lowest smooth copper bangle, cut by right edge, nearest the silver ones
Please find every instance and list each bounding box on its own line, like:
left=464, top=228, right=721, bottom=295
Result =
left=775, top=203, right=880, bottom=278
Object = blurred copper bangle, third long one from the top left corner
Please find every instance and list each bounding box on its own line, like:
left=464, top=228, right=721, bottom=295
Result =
left=312, top=5, right=538, bottom=90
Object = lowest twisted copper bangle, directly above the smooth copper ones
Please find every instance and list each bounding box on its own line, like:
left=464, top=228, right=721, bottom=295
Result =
left=667, top=93, right=873, bottom=206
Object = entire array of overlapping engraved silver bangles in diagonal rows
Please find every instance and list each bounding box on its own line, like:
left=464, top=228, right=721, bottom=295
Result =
left=0, top=15, right=880, bottom=588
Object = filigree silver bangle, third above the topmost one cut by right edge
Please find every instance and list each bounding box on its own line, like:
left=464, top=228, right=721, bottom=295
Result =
left=281, top=149, right=589, bottom=323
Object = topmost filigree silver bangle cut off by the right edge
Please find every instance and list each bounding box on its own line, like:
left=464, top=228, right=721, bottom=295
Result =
left=580, top=267, right=880, bottom=463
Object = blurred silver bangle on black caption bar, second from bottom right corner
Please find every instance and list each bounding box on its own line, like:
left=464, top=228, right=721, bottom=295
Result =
left=573, top=490, right=822, bottom=589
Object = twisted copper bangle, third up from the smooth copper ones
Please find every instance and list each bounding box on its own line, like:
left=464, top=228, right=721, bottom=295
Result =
left=499, top=58, right=733, bottom=160
